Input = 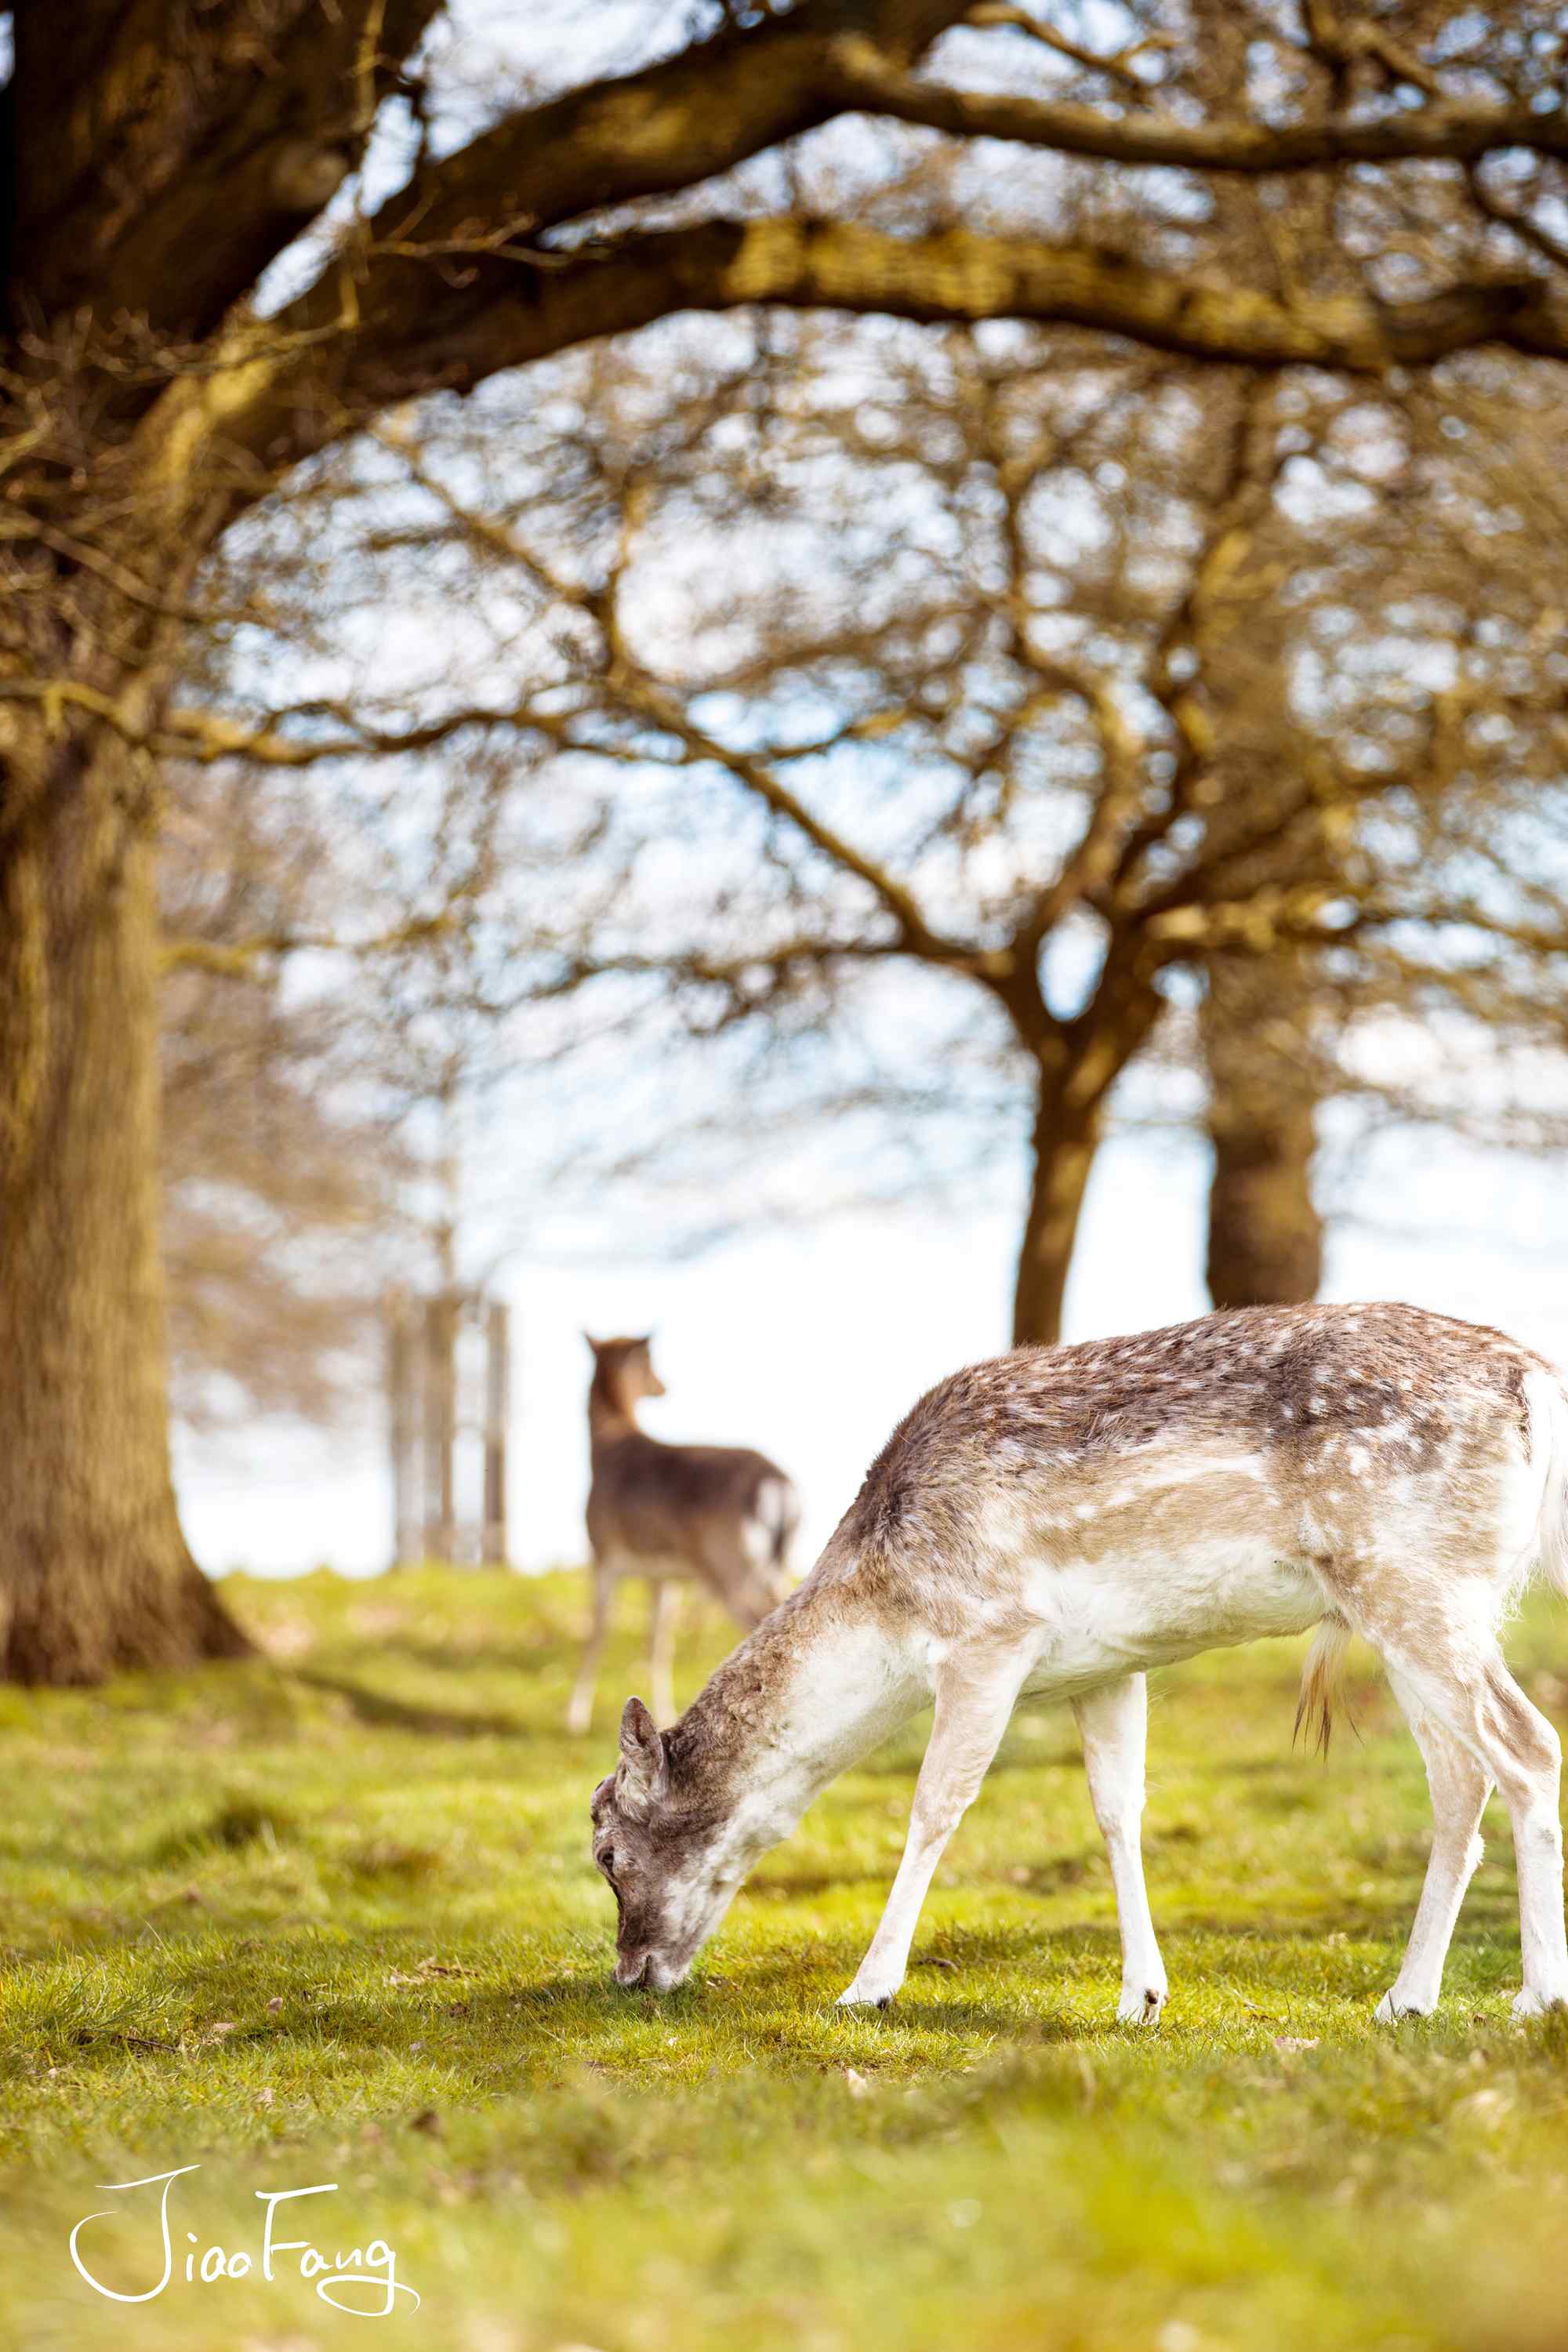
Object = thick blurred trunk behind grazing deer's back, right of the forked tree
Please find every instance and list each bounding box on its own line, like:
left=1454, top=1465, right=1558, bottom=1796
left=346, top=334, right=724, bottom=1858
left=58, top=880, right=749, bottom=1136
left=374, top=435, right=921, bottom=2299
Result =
left=1201, top=957, right=1323, bottom=1308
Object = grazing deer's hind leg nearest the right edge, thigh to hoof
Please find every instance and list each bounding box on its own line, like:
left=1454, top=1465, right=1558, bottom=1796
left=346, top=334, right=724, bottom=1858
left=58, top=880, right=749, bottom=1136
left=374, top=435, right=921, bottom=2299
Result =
left=1361, top=1621, right=1568, bottom=2018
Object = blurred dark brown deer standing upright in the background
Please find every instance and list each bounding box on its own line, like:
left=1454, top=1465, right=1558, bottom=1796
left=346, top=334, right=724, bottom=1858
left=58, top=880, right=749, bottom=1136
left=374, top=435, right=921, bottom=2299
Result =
left=567, top=1331, right=799, bottom=1731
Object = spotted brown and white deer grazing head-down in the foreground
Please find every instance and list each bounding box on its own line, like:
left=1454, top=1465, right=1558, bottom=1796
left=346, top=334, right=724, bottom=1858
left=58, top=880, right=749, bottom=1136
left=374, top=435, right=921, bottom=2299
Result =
left=593, top=1305, right=1568, bottom=2020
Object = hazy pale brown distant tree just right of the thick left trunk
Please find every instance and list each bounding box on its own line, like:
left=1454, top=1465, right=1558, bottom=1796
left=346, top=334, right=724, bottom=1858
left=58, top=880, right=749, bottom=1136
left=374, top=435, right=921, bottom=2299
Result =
left=160, top=767, right=419, bottom=1428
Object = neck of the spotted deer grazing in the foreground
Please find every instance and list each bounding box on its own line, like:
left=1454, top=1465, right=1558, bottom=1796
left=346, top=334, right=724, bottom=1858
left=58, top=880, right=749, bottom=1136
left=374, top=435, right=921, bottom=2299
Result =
left=670, top=1571, right=931, bottom=1875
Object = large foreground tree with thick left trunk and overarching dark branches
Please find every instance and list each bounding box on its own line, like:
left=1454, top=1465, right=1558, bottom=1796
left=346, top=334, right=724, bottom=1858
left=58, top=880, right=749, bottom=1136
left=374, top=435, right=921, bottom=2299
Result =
left=0, top=0, right=1568, bottom=1679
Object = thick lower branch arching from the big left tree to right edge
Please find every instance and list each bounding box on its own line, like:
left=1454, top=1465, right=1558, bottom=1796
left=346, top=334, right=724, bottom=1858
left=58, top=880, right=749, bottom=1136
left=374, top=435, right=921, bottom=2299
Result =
left=169, top=216, right=1568, bottom=524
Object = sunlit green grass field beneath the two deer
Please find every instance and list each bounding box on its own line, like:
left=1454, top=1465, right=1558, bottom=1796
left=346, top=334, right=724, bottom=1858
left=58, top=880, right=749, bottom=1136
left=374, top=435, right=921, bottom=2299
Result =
left=0, top=1573, right=1568, bottom=2352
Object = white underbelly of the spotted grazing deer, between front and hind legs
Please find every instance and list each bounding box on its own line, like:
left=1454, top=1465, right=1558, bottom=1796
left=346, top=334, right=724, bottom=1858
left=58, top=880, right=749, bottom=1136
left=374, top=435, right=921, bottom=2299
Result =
left=1025, top=1538, right=1326, bottom=1693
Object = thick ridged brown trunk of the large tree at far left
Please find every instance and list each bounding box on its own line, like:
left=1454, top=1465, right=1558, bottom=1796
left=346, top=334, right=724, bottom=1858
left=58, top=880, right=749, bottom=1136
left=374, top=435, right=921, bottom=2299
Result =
left=0, top=724, right=249, bottom=1682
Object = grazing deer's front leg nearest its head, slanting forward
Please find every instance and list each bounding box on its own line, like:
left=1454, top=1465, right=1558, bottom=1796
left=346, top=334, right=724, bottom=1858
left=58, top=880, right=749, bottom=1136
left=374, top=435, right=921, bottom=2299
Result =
left=839, top=1658, right=1027, bottom=2009
